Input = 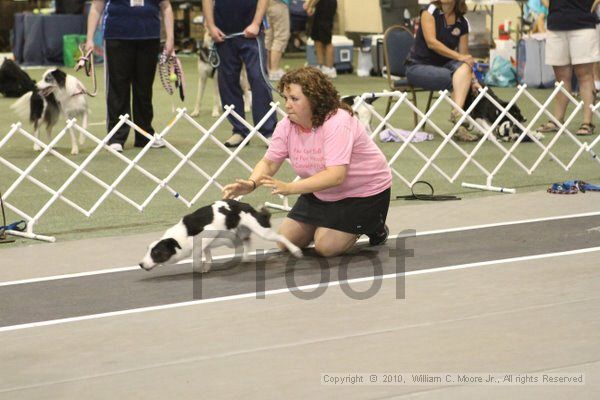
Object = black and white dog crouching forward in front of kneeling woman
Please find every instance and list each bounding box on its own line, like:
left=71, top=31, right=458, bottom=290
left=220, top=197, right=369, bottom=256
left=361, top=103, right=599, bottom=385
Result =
left=139, top=200, right=302, bottom=273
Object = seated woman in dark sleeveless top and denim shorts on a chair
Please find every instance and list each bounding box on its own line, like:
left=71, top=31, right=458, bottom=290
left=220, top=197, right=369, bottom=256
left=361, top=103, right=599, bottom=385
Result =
left=406, top=0, right=479, bottom=142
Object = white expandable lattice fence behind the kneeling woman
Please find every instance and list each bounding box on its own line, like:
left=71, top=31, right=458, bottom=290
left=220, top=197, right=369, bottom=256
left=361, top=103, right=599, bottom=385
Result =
left=0, top=83, right=600, bottom=241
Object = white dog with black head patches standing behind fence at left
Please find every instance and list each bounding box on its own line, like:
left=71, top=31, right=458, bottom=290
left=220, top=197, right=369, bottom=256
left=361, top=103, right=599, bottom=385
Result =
left=10, top=68, right=88, bottom=155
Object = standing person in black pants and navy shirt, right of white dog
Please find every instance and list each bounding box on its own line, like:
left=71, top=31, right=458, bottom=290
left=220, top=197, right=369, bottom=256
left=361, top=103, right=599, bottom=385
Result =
left=85, top=0, right=174, bottom=152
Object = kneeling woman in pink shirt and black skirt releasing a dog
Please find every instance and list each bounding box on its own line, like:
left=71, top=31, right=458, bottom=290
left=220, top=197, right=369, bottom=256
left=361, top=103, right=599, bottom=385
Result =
left=223, top=67, right=392, bottom=257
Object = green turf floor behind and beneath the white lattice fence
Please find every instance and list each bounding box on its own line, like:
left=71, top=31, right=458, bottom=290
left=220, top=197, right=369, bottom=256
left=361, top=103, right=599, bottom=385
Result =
left=0, top=56, right=600, bottom=245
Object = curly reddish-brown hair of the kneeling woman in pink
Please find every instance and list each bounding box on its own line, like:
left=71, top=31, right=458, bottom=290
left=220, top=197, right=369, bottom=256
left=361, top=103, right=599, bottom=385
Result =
left=277, top=67, right=352, bottom=128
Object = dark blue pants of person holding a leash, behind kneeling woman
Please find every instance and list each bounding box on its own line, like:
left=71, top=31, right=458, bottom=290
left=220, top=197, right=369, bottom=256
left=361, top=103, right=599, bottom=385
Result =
left=217, top=35, right=277, bottom=137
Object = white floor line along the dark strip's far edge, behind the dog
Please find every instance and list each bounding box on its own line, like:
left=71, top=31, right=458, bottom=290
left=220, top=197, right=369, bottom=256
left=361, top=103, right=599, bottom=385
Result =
left=0, top=211, right=600, bottom=287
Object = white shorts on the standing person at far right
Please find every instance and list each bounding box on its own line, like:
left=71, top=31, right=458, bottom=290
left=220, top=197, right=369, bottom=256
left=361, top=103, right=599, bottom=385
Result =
left=546, top=29, right=600, bottom=67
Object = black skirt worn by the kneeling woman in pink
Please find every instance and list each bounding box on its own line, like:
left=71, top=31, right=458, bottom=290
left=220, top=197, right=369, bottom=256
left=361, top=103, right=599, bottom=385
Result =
left=288, top=188, right=391, bottom=234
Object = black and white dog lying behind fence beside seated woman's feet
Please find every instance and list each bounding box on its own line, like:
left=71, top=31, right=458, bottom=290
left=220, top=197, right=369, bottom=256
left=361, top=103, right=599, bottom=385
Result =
left=464, top=86, right=544, bottom=142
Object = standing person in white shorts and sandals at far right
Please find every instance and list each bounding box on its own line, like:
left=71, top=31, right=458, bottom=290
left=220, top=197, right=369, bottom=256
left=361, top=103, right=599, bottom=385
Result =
left=538, top=0, right=600, bottom=135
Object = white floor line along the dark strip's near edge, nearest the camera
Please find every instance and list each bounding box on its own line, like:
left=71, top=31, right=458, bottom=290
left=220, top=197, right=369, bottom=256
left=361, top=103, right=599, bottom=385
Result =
left=0, top=247, right=600, bottom=333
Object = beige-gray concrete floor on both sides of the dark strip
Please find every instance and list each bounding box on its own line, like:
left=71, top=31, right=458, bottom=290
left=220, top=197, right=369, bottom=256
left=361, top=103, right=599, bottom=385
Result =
left=0, top=192, right=600, bottom=399
